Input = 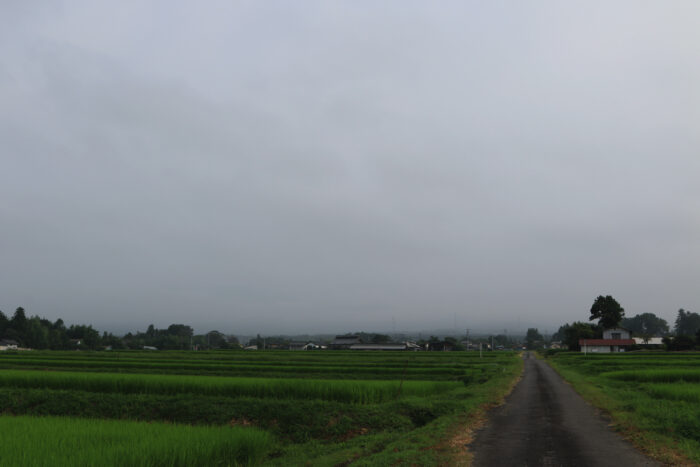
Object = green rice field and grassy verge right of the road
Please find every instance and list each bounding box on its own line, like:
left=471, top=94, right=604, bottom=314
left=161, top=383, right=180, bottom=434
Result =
left=549, top=352, right=700, bottom=465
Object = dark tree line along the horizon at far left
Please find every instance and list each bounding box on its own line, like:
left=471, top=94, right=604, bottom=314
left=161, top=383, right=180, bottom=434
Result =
left=0, top=307, right=238, bottom=350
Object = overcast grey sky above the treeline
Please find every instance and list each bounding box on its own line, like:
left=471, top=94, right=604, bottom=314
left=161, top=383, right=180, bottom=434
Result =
left=0, top=0, right=700, bottom=334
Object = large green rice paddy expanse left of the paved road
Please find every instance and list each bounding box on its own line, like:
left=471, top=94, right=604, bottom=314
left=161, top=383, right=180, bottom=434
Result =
left=0, top=351, right=524, bottom=466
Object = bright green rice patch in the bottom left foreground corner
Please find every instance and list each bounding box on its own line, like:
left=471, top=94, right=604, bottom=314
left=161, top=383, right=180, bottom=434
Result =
left=0, top=416, right=274, bottom=467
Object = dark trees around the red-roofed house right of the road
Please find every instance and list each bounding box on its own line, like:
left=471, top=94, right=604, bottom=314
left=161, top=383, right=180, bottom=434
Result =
left=552, top=295, right=700, bottom=350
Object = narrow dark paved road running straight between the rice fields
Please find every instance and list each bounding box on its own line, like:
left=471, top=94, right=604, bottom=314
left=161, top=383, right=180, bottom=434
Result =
left=469, top=353, right=659, bottom=467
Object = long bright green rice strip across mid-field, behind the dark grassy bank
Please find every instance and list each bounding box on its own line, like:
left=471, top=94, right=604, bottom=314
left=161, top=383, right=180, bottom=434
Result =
left=0, top=370, right=460, bottom=404
